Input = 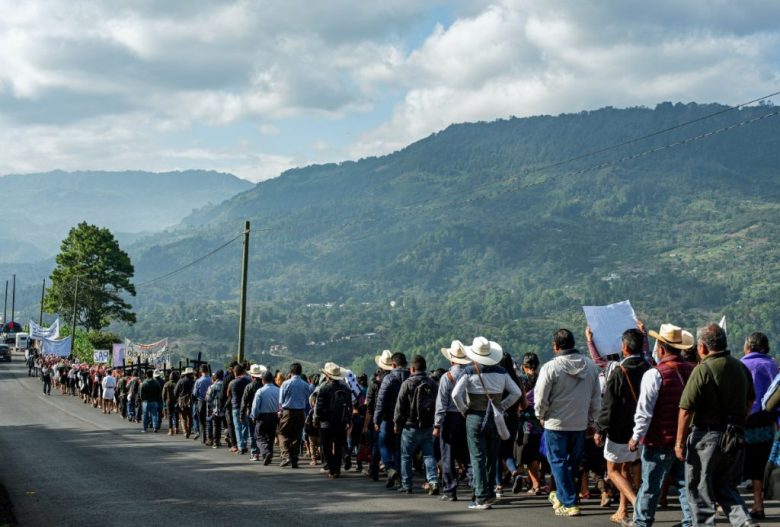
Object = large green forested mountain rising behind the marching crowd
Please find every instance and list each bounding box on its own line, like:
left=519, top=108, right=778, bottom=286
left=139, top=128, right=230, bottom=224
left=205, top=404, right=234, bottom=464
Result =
left=112, top=103, right=780, bottom=376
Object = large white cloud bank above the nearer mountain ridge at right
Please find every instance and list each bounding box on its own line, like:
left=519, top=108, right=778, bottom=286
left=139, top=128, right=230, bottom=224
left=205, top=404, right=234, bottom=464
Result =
left=352, top=0, right=780, bottom=157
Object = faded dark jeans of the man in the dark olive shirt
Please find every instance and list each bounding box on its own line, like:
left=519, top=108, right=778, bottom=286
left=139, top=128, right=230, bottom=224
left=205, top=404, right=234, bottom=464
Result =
left=685, top=428, right=750, bottom=525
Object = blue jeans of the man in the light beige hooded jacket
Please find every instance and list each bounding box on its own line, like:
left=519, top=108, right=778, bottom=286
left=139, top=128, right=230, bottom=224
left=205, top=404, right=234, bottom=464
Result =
left=544, top=429, right=585, bottom=507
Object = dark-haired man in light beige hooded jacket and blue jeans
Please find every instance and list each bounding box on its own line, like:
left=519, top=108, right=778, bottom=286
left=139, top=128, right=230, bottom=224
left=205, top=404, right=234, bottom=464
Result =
left=534, top=329, right=601, bottom=516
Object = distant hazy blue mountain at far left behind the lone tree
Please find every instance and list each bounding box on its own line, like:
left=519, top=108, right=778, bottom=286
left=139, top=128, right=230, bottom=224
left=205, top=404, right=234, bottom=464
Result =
left=0, top=170, right=252, bottom=262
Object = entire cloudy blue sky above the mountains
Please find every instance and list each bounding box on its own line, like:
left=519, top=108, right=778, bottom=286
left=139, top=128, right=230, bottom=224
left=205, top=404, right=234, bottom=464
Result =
left=0, top=0, right=780, bottom=181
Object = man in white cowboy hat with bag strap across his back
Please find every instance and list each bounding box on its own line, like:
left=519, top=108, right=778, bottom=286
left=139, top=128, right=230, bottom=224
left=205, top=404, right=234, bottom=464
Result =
left=452, top=337, right=523, bottom=510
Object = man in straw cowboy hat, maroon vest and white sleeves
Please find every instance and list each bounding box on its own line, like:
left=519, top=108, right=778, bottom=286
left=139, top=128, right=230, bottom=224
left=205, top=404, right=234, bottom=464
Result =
left=624, top=324, right=693, bottom=527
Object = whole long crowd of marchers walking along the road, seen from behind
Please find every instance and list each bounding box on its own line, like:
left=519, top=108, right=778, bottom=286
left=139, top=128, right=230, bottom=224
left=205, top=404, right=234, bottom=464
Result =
left=22, top=322, right=780, bottom=527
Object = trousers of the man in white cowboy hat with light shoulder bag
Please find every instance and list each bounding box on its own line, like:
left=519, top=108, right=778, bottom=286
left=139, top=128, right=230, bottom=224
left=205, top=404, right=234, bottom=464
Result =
left=466, top=413, right=501, bottom=503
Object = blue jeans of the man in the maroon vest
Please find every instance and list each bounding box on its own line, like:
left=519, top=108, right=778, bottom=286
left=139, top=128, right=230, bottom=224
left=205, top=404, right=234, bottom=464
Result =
left=634, top=446, right=692, bottom=527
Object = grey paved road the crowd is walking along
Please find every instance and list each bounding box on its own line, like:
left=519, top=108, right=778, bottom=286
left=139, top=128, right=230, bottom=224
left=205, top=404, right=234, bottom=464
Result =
left=0, top=356, right=780, bottom=527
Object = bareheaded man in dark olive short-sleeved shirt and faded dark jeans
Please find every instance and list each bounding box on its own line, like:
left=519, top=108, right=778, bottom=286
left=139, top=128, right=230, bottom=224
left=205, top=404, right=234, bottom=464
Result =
left=674, top=324, right=756, bottom=527
